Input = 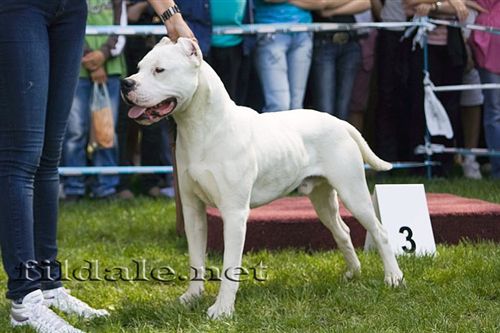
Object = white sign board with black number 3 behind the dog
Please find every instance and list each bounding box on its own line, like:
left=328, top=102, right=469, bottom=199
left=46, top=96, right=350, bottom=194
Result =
left=365, top=184, right=436, bottom=255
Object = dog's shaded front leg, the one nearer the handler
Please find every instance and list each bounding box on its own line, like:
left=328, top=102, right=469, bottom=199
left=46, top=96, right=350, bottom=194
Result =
left=180, top=195, right=207, bottom=304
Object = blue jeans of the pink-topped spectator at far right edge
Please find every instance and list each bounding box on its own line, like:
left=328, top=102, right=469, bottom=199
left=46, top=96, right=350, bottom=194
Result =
left=478, top=68, right=500, bottom=179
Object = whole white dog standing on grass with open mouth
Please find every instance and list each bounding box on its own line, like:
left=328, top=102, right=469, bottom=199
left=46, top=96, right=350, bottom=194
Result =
left=122, top=37, right=403, bottom=318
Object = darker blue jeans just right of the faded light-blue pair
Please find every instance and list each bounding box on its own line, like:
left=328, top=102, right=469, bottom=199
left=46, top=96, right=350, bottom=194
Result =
left=311, top=36, right=361, bottom=120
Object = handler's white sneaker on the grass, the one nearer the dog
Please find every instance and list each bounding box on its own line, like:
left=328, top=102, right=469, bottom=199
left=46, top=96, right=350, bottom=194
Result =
left=43, top=287, right=109, bottom=318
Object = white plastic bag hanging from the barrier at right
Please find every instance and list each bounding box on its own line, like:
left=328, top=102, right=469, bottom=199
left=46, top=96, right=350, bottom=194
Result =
left=424, top=73, right=453, bottom=139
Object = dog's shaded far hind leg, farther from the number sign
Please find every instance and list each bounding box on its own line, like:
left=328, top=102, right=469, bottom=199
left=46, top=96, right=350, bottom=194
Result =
left=309, top=180, right=361, bottom=279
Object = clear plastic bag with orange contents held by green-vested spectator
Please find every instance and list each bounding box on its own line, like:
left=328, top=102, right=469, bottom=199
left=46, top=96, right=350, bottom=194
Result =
left=87, top=83, right=115, bottom=154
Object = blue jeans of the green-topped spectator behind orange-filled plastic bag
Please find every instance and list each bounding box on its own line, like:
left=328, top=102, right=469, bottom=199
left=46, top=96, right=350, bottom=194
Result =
left=62, top=76, right=120, bottom=197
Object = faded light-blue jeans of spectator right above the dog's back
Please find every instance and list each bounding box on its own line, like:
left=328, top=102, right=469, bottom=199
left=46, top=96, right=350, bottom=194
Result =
left=255, top=32, right=312, bottom=112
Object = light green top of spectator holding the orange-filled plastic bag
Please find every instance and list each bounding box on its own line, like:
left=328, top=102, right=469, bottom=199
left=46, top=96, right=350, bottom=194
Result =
left=80, top=0, right=126, bottom=77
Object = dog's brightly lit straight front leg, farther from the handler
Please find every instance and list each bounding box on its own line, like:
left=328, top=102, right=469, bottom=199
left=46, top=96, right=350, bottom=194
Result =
left=208, top=208, right=250, bottom=319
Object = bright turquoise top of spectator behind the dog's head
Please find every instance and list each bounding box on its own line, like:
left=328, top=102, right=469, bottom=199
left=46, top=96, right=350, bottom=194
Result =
left=210, top=0, right=246, bottom=47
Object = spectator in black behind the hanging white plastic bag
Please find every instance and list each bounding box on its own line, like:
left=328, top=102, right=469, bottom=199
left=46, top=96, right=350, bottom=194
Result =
left=404, top=0, right=467, bottom=176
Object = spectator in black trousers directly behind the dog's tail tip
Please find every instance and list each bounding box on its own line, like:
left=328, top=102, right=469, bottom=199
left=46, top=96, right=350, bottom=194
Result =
left=372, top=0, right=412, bottom=161
